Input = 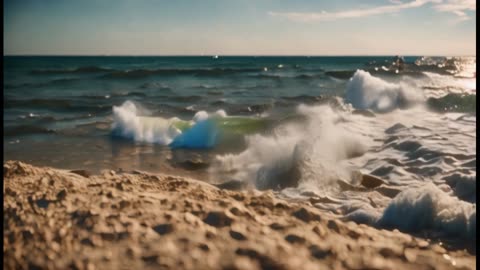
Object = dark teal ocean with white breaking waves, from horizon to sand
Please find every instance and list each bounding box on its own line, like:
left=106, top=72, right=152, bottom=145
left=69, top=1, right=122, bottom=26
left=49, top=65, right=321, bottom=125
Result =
left=3, top=56, right=476, bottom=249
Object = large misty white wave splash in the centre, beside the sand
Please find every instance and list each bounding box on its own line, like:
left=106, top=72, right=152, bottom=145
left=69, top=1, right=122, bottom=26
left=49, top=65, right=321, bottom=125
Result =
left=210, top=105, right=365, bottom=189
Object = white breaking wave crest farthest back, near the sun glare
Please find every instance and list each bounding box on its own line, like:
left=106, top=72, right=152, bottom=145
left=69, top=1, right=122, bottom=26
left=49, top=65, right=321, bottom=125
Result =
left=345, top=70, right=424, bottom=112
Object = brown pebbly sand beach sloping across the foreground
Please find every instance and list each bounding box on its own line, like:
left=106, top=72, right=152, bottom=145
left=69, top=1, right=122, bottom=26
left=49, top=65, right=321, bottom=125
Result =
left=3, top=161, right=476, bottom=269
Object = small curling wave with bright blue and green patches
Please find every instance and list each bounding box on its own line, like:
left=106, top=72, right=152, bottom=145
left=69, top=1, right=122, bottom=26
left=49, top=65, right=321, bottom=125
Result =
left=112, top=101, right=266, bottom=148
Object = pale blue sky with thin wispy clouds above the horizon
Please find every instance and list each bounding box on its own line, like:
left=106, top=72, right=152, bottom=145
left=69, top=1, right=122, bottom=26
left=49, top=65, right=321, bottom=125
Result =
left=3, top=0, right=476, bottom=56
